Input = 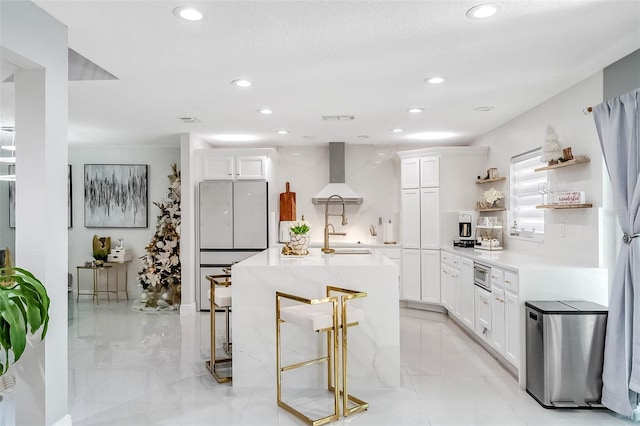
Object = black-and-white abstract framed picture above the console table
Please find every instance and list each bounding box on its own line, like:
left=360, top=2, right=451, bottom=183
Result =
left=84, top=164, right=148, bottom=228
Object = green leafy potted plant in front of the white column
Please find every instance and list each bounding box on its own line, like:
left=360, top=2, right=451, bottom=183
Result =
left=0, top=265, right=50, bottom=376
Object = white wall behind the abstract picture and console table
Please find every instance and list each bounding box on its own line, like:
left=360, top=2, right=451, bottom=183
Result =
left=68, top=145, right=181, bottom=303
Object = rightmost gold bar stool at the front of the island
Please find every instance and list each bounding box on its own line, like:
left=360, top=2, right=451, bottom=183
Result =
left=327, top=286, right=369, bottom=417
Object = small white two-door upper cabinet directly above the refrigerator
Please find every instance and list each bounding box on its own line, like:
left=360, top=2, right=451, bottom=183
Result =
left=202, top=154, right=267, bottom=180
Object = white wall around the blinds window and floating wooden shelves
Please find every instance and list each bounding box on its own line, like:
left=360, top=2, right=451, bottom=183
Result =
left=473, top=72, right=611, bottom=267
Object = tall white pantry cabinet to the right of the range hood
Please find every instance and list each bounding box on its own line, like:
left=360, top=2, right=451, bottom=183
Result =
left=398, top=147, right=488, bottom=305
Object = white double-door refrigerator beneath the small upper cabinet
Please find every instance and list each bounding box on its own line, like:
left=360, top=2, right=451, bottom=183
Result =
left=197, top=181, right=269, bottom=310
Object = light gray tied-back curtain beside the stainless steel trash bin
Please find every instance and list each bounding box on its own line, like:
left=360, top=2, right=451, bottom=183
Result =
left=593, top=89, right=640, bottom=420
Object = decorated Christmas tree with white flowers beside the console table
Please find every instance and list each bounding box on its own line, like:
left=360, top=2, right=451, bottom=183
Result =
left=138, top=164, right=181, bottom=309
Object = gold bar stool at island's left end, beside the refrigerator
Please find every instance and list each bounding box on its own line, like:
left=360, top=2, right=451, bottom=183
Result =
left=206, top=269, right=232, bottom=383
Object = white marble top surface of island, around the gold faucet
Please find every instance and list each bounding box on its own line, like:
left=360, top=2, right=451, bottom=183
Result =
left=233, top=246, right=397, bottom=268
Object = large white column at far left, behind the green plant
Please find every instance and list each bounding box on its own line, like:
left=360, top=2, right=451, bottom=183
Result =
left=0, top=1, right=71, bottom=425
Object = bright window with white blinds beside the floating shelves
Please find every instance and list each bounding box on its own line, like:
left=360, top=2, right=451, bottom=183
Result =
left=509, top=148, right=547, bottom=241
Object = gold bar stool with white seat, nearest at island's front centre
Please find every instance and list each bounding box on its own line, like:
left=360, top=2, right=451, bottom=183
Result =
left=276, top=292, right=340, bottom=426
